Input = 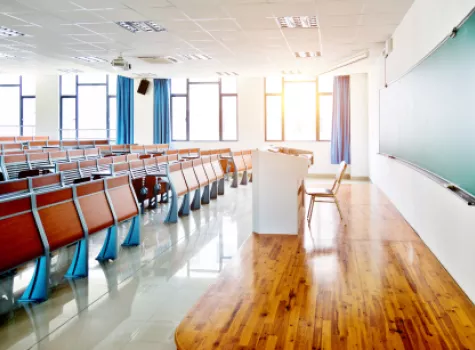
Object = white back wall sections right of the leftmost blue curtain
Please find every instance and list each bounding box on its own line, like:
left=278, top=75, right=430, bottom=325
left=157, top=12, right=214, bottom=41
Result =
left=135, top=74, right=369, bottom=177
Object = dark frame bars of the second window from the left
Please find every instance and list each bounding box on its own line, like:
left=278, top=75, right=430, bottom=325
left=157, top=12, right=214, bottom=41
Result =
left=59, top=74, right=117, bottom=140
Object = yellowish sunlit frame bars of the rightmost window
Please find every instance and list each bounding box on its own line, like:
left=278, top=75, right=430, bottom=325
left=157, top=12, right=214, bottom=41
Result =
left=264, top=76, right=333, bottom=142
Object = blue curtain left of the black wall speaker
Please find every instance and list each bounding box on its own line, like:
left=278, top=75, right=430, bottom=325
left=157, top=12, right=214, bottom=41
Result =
left=117, top=75, right=134, bottom=145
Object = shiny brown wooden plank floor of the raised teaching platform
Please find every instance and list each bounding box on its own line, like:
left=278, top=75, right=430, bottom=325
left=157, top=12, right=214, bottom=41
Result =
left=175, top=184, right=475, bottom=350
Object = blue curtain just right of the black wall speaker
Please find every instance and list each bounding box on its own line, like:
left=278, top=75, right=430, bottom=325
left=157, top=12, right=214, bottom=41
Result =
left=153, top=79, right=170, bottom=144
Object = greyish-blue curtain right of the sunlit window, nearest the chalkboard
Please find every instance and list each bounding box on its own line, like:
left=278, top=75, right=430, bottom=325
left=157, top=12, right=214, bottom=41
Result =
left=331, top=75, right=351, bottom=164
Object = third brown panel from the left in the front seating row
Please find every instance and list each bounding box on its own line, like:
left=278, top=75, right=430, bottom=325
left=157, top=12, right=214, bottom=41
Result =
left=75, top=180, right=114, bottom=235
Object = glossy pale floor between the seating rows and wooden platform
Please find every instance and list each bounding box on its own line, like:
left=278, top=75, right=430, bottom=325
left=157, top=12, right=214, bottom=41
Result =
left=0, top=182, right=252, bottom=350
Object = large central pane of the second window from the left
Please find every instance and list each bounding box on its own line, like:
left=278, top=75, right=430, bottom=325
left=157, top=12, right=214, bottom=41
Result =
left=78, top=86, right=107, bottom=139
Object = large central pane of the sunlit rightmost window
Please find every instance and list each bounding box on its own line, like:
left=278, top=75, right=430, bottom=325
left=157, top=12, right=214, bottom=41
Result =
left=284, top=83, right=317, bottom=141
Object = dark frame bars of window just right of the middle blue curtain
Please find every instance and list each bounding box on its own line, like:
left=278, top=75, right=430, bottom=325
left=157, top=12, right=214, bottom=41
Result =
left=170, top=78, right=239, bottom=142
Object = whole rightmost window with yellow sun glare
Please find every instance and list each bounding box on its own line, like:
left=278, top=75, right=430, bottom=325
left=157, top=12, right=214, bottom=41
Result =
left=265, top=76, right=333, bottom=141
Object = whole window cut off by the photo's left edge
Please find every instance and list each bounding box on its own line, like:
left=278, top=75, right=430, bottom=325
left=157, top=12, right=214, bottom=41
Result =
left=0, top=75, right=36, bottom=136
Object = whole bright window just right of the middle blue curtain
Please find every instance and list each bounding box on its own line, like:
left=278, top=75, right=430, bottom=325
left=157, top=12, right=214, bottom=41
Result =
left=170, top=77, right=238, bottom=141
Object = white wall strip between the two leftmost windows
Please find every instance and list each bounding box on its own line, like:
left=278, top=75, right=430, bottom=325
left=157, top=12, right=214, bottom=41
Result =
left=36, top=75, right=59, bottom=140
